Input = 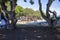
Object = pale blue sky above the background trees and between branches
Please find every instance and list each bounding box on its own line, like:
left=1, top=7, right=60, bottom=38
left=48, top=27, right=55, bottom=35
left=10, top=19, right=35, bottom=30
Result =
left=17, top=0, right=60, bottom=15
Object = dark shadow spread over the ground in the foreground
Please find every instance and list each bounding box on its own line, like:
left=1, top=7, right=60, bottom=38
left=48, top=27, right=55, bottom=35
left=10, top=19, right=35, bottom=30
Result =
left=0, top=25, right=59, bottom=40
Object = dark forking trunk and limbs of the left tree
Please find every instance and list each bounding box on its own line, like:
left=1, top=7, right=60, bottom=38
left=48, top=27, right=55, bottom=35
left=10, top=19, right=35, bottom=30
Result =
left=0, top=0, right=17, bottom=28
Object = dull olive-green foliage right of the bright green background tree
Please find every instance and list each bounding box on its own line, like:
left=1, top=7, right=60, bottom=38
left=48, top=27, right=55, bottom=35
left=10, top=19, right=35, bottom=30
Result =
left=23, top=8, right=41, bottom=18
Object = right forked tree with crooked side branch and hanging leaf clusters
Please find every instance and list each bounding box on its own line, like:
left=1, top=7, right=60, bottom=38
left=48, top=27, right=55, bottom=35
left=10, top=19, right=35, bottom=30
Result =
left=24, top=0, right=60, bottom=27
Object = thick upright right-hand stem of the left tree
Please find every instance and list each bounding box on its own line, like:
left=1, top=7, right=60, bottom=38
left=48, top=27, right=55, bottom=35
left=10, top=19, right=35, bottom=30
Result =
left=10, top=0, right=17, bottom=28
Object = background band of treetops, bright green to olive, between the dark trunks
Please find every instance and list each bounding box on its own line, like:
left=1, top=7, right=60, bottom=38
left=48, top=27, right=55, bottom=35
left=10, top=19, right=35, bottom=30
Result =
left=15, top=6, right=41, bottom=18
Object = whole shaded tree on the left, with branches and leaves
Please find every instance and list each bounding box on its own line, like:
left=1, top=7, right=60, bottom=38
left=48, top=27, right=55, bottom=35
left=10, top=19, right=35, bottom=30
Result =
left=0, top=0, right=17, bottom=28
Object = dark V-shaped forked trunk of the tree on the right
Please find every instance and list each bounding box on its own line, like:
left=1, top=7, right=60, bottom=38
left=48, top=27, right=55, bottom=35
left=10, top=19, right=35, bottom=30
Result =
left=38, top=0, right=54, bottom=27
